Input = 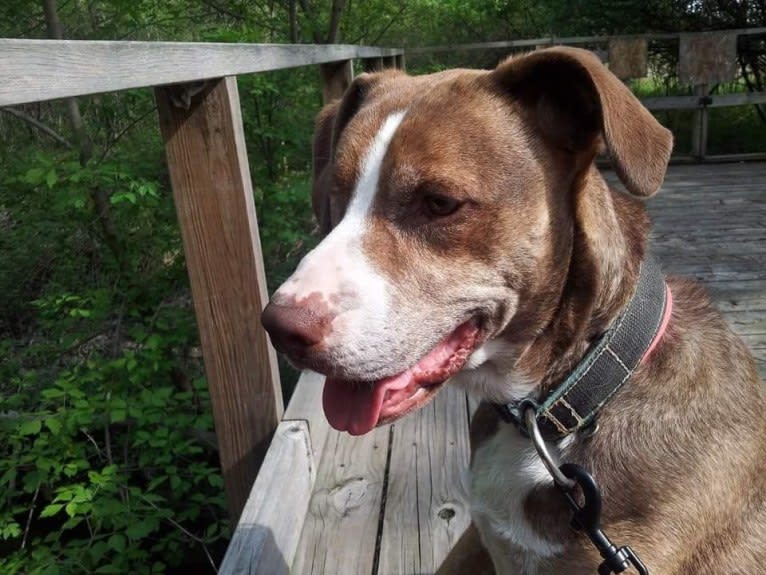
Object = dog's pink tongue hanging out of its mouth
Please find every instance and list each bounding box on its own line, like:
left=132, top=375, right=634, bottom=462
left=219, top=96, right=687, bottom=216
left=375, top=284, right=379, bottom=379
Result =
left=322, top=323, right=477, bottom=435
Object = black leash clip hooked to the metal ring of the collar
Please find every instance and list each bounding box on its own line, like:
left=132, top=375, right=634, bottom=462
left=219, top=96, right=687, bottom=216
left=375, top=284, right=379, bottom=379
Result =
left=559, top=463, right=649, bottom=575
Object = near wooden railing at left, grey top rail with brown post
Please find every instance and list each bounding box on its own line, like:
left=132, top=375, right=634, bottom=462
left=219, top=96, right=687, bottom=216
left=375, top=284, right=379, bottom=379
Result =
left=0, top=39, right=403, bottom=522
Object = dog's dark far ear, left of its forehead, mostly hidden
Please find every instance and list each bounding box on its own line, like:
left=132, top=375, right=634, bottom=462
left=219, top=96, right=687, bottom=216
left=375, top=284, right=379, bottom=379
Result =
left=311, top=74, right=384, bottom=236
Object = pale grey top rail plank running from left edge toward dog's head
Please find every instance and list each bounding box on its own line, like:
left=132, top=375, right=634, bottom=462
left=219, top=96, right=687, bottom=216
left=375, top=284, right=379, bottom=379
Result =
left=0, top=39, right=402, bottom=106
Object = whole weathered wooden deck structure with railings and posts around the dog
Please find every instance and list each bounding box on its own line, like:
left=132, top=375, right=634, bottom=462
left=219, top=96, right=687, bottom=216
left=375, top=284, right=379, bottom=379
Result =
left=0, top=29, right=766, bottom=575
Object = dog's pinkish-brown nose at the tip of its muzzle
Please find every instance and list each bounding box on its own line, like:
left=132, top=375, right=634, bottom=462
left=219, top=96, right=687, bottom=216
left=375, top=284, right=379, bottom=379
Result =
left=261, top=301, right=332, bottom=357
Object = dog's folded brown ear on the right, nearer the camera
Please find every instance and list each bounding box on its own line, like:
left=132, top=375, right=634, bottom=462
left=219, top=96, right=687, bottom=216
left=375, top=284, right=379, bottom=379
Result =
left=492, top=47, right=673, bottom=197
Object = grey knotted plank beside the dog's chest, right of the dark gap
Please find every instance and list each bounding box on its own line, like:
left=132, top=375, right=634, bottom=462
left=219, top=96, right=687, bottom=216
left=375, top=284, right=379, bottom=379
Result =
left=378, top=384, right=471, bottom=574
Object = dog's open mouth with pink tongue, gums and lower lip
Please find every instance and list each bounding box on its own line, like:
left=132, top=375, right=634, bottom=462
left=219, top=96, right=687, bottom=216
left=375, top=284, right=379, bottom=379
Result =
left=322, top=321, right=480, bottom=435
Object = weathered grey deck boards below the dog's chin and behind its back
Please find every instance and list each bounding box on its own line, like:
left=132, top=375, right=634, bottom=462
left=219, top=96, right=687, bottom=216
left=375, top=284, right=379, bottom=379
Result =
left=221, top=164, right=766, bottom=575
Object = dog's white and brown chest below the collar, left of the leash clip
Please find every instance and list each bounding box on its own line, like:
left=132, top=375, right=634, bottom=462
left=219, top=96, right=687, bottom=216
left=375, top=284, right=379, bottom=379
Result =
left=464, top=425, right=564, bottom=575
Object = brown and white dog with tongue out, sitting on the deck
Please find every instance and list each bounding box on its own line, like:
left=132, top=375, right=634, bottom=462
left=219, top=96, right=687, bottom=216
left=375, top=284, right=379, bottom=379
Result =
left=262, top=47, right=766, bottom=575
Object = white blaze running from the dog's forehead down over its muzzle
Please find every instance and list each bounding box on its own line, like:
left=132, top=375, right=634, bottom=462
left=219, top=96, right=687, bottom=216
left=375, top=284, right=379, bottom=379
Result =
left=275, top=111, right=405, bottom=372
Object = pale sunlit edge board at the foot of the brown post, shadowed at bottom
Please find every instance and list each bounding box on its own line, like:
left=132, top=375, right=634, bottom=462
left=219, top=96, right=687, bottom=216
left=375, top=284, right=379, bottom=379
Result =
left=218, top=421, right=316, bottom=575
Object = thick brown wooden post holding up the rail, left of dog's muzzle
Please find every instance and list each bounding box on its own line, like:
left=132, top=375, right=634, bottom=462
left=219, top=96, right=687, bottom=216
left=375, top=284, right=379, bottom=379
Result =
left=156, top=77, right=283, bottom=524
